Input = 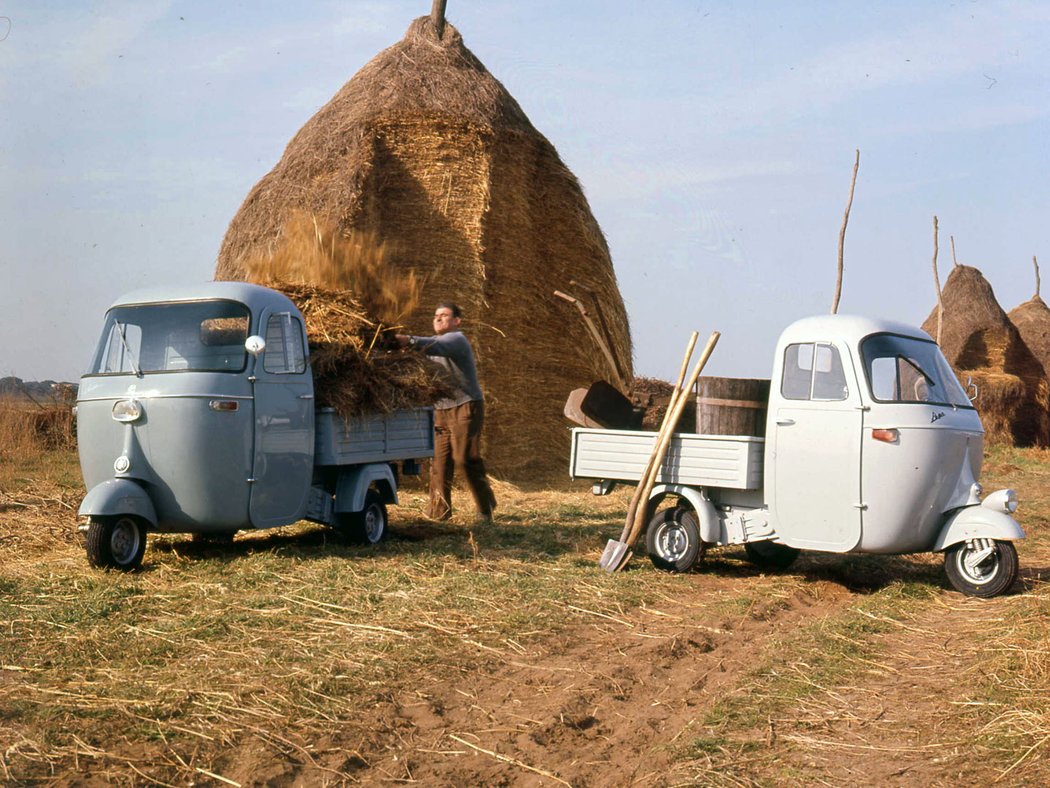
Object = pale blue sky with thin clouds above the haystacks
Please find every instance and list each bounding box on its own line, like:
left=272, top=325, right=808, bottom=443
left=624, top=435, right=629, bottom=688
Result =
left=0, top=0, right=1050, bottom=379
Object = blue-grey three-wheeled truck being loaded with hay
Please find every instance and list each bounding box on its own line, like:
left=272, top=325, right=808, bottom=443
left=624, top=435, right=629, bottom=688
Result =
left=77, top=282, right=434, bottom=569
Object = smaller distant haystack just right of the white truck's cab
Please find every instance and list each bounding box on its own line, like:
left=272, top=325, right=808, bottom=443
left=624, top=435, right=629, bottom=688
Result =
left=922, top=266, right=1050, bottom=447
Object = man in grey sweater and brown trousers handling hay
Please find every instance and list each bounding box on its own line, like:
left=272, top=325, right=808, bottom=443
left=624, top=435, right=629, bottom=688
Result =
left=397, top=302, right=496, bottom=522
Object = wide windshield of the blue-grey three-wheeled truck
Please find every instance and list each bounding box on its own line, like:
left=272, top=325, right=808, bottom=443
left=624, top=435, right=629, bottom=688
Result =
left=87, top=300, right=249, bottom=375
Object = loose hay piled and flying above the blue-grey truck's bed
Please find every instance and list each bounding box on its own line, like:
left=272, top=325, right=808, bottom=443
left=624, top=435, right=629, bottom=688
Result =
left=245, top=213, right=448, bottom=418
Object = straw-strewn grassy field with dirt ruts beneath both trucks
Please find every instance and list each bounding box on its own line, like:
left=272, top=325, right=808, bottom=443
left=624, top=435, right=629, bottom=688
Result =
left=0, top=409, right=1050, bottom=785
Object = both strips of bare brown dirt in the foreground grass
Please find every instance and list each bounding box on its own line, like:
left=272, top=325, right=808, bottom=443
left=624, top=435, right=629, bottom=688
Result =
left=206, top=558, right=1038, bottom=786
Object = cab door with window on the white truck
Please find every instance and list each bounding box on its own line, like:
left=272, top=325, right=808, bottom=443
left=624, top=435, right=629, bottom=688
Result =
left=765, top=341, right=863, bottom=553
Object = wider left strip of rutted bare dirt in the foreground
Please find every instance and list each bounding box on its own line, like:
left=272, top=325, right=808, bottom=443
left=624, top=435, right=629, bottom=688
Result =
left=310, top=576, right=854, bottom=786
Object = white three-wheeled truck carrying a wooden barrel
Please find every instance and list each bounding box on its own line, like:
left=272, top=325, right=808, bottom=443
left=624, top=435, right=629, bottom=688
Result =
left=570, top=315, right=1025, bottom=597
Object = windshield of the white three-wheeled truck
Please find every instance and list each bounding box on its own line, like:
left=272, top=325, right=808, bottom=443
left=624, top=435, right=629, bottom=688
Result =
left=860, top=334, right=973, bottom=408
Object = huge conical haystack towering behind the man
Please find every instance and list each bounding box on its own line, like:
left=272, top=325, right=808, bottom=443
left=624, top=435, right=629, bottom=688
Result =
left=215, top=17, right=631, bottom=478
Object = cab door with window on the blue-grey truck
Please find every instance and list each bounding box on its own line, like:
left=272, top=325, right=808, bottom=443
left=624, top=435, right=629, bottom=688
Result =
left=249, top=311, right=314, bottom=528
